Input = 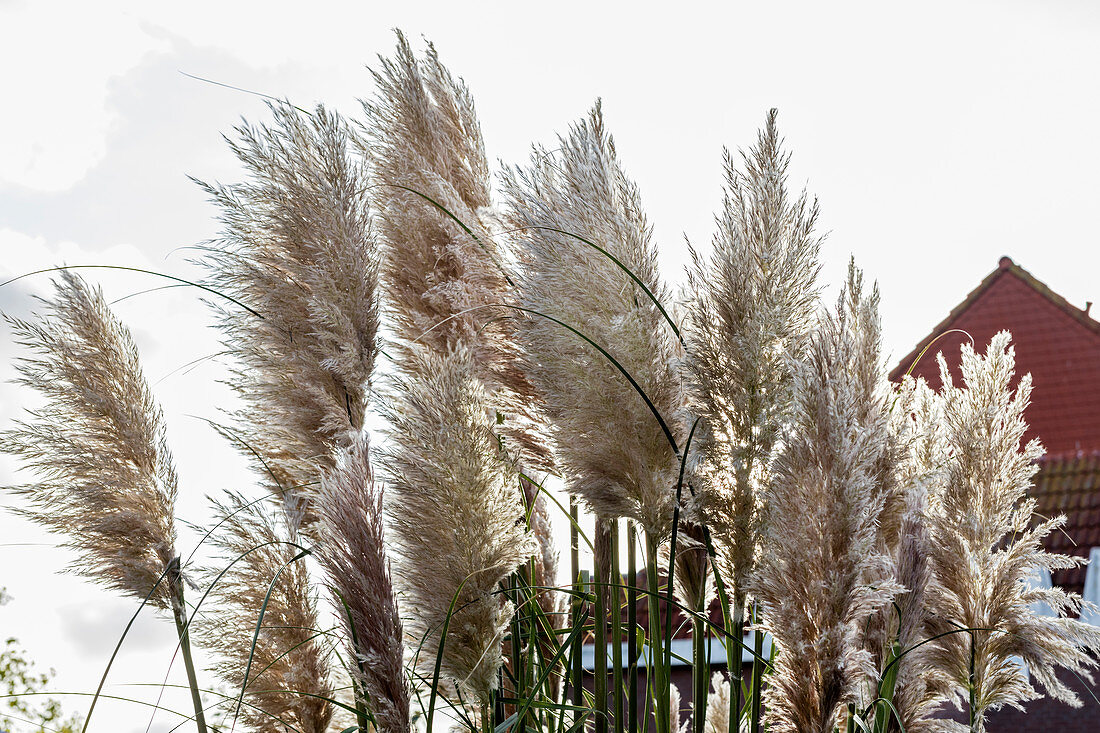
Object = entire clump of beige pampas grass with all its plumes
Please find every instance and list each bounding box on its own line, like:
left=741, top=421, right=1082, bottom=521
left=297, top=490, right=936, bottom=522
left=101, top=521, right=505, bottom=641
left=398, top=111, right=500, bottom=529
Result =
left=0, top=33, right=1100, bottom=733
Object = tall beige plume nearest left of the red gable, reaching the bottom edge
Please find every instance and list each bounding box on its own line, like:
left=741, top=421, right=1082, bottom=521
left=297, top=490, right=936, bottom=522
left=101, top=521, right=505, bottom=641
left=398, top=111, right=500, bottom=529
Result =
left=750, top=265, right=901, bottom=733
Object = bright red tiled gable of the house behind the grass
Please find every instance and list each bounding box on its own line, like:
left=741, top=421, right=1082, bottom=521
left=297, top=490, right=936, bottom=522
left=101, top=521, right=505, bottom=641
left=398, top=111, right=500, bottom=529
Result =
left=890, top=258, right=1100, bottom=456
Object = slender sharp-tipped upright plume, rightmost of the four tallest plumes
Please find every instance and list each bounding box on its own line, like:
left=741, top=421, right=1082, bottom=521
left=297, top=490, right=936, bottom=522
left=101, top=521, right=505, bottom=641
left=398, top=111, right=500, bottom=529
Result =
left=685, top=109, right=821, bottom=614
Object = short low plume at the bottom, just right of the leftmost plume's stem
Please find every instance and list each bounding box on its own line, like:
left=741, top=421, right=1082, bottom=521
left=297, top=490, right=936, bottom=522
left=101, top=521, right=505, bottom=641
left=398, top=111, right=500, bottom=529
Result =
left=196, top=493, right=332, bottom=733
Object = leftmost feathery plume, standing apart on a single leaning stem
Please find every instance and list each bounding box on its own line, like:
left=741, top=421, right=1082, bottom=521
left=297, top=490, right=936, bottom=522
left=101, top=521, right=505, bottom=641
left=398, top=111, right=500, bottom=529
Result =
left=0, top=271, right=176, bottom=609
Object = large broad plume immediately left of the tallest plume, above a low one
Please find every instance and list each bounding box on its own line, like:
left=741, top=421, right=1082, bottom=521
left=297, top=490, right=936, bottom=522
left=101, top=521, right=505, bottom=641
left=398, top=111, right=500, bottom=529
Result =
left=200, top=105, right=378, bottom=528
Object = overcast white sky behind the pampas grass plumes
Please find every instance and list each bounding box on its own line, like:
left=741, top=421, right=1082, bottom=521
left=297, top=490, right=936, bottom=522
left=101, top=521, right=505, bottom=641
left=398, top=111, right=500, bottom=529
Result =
left=0, top=0, right=1100, bottom=733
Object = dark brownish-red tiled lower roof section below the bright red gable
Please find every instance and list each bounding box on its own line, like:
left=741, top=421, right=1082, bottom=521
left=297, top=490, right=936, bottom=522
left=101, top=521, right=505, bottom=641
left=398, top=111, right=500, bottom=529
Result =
left=1032, top=451, right=1100, bottom=593
